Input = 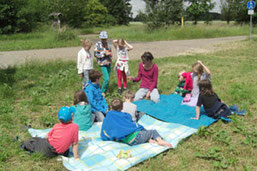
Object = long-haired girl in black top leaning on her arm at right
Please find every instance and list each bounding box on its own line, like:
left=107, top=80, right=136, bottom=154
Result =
left=191, top=79, right=231, bottom=120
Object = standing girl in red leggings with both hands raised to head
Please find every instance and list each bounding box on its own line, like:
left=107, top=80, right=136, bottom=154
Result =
left=113, top=39, right=133, bottom=94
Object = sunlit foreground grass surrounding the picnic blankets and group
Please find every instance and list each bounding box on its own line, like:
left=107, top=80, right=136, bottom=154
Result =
left=0, top=38, right=257, bottom=170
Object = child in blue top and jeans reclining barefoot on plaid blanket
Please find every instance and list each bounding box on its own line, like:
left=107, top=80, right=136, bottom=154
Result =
left=101, top=99, right=172, bottom=147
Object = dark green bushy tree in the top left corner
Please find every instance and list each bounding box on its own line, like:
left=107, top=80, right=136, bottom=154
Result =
left=0, top=0, right=46, bottom=34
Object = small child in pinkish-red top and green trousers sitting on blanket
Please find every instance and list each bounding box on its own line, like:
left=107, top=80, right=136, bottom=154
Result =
left=174, top=70, right=193, bottom=97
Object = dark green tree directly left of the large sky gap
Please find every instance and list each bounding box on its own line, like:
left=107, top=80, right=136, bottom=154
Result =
left=100, top=0, right=132, bottom=24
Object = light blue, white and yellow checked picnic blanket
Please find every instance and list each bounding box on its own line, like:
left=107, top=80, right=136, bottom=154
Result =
left=29, top=115, right=197, bottom=171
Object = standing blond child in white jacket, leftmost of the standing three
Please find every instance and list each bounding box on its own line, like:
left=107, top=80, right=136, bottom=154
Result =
left=77, top=40, right=93, bottom=89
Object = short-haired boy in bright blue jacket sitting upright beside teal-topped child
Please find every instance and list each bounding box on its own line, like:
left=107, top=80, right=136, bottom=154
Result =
left=84, top=70, right=108, bottom=122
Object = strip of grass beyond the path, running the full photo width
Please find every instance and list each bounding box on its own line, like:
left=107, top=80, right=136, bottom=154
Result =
left=0, top=21, right=257, bottom=51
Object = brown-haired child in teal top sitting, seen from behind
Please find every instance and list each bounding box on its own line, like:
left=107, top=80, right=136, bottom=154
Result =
left=73, top=90, right=95, bottom=131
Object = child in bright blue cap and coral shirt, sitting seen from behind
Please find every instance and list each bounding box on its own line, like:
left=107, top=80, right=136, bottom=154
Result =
left=21, top=107, right=79, bottom=159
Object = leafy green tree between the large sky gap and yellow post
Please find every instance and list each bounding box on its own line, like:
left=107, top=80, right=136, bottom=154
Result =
left=145, top=0, right=183, bottom=29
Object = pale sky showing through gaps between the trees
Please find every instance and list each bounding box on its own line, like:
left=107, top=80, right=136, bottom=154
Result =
left=130, top=0, right=220, bottom=18
